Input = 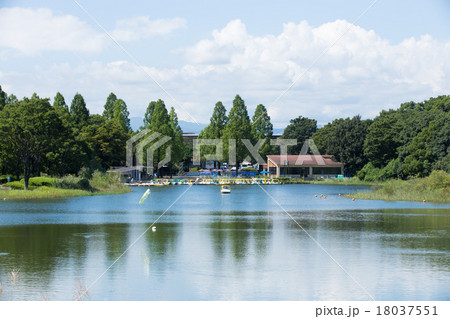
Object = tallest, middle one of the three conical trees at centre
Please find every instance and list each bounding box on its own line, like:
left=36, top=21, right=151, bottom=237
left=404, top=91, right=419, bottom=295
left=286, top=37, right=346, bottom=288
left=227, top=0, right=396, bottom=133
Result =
left=223, top=95, right=252, bottom=175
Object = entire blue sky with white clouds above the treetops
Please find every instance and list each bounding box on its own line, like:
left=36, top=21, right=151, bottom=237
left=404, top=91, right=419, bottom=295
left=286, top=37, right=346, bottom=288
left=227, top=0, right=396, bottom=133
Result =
left=0, top=0, right=450, bottom=128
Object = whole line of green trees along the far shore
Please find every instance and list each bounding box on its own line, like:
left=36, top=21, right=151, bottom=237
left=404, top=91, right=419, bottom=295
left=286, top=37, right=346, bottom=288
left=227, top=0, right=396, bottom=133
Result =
left=0, top=88, right=450, bottom=190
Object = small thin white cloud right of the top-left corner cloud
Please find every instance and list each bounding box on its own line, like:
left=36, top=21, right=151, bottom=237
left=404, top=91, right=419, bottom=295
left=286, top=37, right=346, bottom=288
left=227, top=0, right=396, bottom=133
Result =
left=111, top=16, right=187, bottom=41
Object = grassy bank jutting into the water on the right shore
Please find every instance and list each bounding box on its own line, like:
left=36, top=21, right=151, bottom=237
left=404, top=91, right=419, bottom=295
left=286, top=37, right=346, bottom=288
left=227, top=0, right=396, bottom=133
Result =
left=347, top=171, right=450, bottom=203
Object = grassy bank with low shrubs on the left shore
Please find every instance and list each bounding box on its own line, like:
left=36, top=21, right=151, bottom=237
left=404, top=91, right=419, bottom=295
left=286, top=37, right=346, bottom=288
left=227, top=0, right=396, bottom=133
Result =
left=0, top=172, right=131, bottom=200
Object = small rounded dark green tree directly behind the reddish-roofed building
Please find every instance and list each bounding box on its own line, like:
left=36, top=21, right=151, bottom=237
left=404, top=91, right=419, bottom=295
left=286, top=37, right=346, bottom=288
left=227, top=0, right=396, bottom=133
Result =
left=281, top=116, right=317, bottom=155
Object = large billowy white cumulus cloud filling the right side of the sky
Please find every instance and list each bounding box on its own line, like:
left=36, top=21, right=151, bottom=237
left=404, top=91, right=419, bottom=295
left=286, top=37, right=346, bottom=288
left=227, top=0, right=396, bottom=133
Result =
left=179, top=20, right=450, bottom=123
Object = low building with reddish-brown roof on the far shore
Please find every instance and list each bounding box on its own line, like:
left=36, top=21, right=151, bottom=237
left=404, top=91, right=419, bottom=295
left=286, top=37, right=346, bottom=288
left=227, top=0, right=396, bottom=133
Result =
left=267, top=155, right=344, bottom=179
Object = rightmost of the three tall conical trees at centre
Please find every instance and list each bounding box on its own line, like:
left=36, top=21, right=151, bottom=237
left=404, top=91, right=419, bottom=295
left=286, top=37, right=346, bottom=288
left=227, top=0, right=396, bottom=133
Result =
left=252, top=104, right=273, bottom=164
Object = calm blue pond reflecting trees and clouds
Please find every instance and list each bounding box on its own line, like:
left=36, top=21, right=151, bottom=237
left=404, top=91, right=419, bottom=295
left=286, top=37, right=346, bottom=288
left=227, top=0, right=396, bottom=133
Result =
left=0, top=185, right=450, bottom=300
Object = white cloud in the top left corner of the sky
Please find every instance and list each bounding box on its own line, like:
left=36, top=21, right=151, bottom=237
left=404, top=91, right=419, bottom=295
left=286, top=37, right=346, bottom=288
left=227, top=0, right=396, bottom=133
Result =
left=0, top=7, right=106, bottom=55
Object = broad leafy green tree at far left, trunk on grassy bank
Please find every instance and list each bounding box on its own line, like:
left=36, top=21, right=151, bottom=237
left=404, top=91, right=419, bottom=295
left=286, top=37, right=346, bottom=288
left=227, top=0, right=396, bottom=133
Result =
left=0, top=94, right=62, bottom=190
